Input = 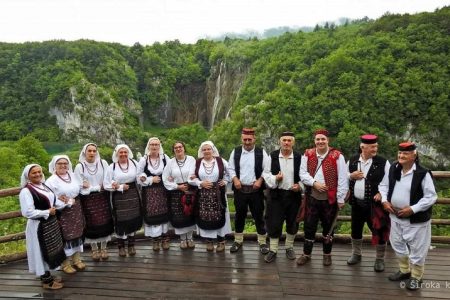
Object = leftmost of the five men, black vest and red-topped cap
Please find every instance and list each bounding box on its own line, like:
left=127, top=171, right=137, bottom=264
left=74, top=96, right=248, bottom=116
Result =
left=228, top=128, right=269, bottom=254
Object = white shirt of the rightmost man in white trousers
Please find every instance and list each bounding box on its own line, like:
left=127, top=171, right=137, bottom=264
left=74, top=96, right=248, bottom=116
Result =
left=378, top=164, right=437, bottom=224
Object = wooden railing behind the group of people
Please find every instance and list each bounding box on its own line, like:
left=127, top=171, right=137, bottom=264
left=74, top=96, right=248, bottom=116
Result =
left=0, top=171, right=450, bottom=263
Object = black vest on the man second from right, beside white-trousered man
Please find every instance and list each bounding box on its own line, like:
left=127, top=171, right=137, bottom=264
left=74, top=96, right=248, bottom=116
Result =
left=348, top=154, right=386, bottom=204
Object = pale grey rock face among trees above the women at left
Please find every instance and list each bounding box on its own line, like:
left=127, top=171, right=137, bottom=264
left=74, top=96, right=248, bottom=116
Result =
left=49, top=81, right=141, bottom=145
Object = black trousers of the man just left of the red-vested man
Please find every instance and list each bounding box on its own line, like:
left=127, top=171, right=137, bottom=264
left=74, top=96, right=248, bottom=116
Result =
left=266, top=189, right=301, bottom=238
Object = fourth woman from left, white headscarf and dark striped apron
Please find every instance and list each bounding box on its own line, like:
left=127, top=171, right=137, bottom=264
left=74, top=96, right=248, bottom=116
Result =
left=103, top=144, right=142, bottom=257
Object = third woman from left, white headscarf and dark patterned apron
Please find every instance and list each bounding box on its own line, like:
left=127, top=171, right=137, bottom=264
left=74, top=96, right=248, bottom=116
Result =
left=74, top=143, right=114, bottom=261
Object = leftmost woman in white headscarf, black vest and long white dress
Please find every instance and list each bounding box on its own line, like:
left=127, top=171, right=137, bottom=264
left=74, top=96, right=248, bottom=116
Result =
left=19, top=164, right=66, bottom=290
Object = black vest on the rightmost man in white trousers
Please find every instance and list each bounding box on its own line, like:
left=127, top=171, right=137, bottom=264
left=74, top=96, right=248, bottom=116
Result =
left=387, top=161, right=432, bottom=223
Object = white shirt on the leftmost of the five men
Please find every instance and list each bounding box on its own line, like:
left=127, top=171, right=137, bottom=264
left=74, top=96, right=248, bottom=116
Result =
left=228, top=147, right=269, bottom=185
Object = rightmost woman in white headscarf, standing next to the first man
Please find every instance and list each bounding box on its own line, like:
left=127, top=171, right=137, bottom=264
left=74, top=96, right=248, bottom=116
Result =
left=188, top=141, right=231, bottom=252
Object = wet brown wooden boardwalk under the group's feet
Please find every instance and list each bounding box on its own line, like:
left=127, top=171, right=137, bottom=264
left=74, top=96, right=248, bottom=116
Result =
left=0, top=241, right=450, bottom=300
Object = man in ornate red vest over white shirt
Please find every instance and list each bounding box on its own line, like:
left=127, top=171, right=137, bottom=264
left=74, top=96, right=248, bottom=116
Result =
left=297, top=129, right=348, bottom=266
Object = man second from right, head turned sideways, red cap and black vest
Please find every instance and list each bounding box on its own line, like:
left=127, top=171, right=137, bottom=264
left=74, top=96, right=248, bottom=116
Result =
left=347, top=134, right=391, bottom=272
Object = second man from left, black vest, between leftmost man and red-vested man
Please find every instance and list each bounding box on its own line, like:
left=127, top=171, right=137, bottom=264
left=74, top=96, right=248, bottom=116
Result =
left=263, top=132, right=301, bottom=263
